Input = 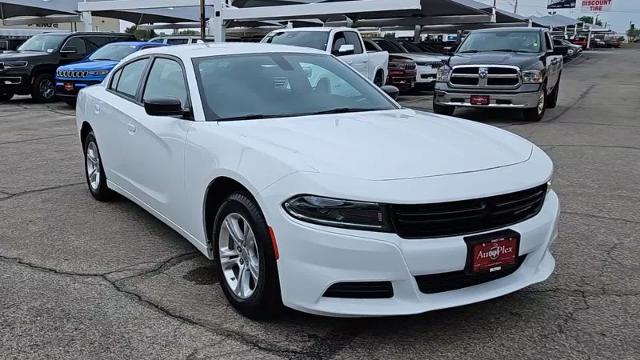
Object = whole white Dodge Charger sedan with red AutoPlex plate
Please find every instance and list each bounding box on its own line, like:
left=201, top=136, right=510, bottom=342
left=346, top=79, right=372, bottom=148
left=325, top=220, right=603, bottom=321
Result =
left=77, top=44, right=559, bottom=318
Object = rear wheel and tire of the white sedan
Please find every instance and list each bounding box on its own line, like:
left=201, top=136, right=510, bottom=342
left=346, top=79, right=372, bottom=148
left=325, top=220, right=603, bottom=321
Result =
left=84, top=131, right=113, bottom=202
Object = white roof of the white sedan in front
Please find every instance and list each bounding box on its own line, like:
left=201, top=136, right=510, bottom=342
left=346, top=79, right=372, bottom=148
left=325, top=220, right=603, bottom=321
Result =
left=131, top=42, right=326, bottom=60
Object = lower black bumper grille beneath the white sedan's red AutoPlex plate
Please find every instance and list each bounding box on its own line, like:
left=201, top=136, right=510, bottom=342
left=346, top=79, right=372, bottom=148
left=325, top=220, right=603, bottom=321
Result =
left=416, top=255, right=527, bottom=294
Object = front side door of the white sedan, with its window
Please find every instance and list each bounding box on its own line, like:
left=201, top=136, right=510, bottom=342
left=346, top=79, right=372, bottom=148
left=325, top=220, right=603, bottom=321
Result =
left=128, top=56, right=192, bottom=224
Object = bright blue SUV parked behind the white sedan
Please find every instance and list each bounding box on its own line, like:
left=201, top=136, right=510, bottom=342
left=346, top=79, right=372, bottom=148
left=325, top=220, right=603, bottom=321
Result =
left=56, top=42, right=166, bottom=104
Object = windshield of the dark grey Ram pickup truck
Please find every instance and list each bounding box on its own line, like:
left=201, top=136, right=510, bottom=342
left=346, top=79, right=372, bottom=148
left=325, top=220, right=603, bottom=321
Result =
left=457, top=31, right=541, bottom=54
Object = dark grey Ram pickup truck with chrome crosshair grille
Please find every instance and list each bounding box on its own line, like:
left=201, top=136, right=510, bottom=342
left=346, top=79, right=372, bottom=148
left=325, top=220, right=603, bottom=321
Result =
left=433, top=28, right=562, bottom=121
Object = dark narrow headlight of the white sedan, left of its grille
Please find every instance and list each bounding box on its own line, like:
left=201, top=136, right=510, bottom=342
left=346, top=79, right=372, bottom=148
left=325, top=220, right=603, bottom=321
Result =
left=283, top=195, right=391, bottom=232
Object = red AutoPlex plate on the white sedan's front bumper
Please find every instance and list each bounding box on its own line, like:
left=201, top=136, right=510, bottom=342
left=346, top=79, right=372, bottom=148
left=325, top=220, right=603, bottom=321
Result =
left=471, top=237, right=518, bottom=272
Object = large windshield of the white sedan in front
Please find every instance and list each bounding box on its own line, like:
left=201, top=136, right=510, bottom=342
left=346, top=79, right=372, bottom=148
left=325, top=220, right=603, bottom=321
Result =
left=193, top=53, right=397, bottom=121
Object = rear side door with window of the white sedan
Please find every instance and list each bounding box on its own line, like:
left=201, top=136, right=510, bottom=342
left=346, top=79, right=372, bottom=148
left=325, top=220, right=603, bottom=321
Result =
left=98, top=57, right=151, bottom=190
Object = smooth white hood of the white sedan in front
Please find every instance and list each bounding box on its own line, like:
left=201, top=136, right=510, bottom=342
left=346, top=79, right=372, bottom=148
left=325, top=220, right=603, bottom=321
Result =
left=220, top=109, right=533, bottom=181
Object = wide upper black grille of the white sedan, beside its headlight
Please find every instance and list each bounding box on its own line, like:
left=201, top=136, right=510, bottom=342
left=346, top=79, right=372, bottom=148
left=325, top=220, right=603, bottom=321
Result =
left=390, top=184, right=547, bottom=239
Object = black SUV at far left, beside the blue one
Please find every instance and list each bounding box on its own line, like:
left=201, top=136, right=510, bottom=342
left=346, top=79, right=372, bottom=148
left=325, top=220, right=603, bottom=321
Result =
left=0, top=32, right=135, bottom=102
